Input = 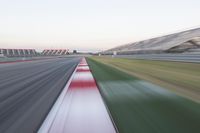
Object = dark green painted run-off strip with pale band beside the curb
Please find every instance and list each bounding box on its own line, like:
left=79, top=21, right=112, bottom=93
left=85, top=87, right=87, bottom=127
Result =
left=88, top=59, right=200, bottom=133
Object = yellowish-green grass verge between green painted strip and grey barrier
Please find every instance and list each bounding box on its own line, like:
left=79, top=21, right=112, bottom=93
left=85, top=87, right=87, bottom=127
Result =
left=88, top=57, right=200, bottom=102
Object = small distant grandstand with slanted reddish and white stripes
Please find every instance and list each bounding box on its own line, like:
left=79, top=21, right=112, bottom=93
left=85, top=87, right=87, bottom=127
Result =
left=41, top=49, right=69, bottom=56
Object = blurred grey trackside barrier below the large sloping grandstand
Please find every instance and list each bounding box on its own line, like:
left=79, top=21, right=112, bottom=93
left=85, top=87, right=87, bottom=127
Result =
left=115, top=53, right=200, bottom=63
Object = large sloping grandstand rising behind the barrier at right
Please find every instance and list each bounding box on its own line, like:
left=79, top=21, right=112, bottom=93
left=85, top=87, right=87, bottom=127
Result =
left=104, top=28, right=200, bottom=55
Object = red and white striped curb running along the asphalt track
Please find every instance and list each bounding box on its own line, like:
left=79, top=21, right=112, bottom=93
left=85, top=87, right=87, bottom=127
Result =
left=38, top=59, right=116, bottom=133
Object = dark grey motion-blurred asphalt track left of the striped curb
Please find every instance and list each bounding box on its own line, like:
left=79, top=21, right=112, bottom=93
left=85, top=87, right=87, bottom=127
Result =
left=0, top=57, right=80, bottom=133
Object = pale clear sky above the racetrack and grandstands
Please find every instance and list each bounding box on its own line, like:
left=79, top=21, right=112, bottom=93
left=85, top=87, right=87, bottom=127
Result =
left=0, top=0, right=200, bottom=51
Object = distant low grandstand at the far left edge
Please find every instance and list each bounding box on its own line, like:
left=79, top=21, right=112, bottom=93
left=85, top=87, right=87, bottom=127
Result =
left=0, top=49, right=37, bottom=57
